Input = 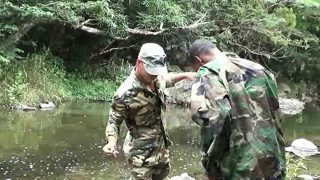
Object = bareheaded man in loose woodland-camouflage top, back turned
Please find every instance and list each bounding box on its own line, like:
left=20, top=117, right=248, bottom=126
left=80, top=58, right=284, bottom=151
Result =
left=189, top=40, right=285, bottom=180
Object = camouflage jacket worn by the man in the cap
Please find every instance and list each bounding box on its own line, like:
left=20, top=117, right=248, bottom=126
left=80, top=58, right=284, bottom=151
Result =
left=106, top=71, right=174, bottom=165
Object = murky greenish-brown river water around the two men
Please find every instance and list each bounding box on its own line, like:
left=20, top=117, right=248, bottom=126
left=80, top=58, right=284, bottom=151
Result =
left=0, top=102, right=320, bottom=179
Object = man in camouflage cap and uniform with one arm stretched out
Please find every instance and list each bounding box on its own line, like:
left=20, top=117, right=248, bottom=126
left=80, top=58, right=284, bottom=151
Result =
left=103, top=43, right=194, bottom=180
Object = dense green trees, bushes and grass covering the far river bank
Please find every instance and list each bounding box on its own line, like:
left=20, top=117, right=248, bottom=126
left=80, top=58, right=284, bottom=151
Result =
left=0, top=0, right=320, bottom=104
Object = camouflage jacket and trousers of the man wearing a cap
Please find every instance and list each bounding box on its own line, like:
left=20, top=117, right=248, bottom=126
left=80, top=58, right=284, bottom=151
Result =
left=106, top=71, right=173, bottom=179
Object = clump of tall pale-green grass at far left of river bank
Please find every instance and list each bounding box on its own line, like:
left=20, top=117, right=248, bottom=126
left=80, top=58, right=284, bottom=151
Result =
left=0, top=50, right=65, bottom=104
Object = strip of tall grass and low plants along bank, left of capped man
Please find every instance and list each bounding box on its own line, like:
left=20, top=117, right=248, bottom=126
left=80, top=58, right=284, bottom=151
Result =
left=0, top=50, right=124, bottom=105
